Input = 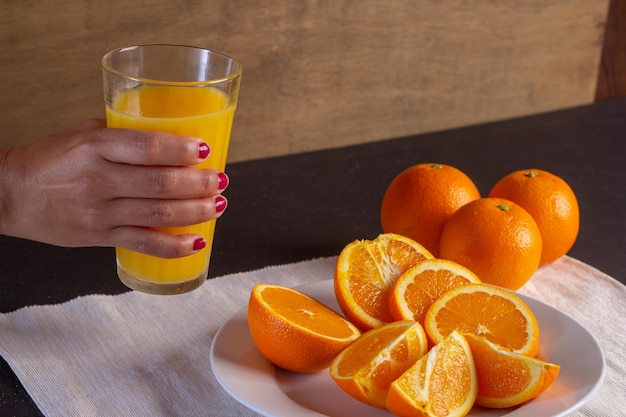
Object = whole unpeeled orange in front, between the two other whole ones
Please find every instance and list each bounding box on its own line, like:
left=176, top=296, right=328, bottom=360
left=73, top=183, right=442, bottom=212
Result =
left=440, top=198, right=542, bottom=290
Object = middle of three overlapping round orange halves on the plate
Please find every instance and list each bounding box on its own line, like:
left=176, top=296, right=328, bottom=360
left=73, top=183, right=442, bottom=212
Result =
left=389, top=259, right=481, bottom=325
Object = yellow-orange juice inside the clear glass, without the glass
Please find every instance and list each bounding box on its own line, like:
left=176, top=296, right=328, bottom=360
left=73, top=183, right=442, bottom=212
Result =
left=106, top=85, right=235, bottom=292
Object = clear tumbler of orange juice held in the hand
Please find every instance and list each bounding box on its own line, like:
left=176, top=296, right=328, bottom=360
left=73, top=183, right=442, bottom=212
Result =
left=102, top=45, right=242, bottom=294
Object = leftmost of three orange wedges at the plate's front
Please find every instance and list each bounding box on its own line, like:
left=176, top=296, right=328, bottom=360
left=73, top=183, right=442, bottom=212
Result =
left=330, top=321, right=428, bottom=408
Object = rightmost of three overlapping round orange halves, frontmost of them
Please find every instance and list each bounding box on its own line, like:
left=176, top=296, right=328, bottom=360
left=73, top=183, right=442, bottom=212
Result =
left=424, top=284, right=539, bottom=356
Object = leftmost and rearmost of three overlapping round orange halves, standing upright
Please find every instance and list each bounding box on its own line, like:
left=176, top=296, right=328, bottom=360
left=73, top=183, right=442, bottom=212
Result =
left=334, top=233, right=433, bottom=330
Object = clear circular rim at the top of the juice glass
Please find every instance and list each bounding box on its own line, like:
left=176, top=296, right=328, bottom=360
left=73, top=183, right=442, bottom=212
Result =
left=101, top=43, right=243, bottom=87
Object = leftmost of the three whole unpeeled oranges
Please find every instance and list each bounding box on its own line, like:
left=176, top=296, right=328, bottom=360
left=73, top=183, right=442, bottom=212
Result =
left=380, top=163, right=480, bottom=257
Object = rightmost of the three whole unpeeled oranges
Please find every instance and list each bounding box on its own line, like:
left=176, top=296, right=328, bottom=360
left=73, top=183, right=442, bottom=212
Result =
left=489, top=169, right=580, bottom=265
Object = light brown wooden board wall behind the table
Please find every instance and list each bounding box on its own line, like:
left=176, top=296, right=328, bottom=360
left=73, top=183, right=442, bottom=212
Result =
left=0, top=0, right=604, bottom=162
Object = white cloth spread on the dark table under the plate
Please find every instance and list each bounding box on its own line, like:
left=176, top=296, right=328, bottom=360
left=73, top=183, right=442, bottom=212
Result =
left=0, top=256, right=626, bottom=417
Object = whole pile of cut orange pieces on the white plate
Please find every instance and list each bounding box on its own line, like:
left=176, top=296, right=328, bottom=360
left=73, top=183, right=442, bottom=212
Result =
left=248, top=234, right=560, bottom=417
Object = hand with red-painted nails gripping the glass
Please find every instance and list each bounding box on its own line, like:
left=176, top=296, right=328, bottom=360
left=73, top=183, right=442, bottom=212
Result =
left=0, top=120, right=228, bottom=258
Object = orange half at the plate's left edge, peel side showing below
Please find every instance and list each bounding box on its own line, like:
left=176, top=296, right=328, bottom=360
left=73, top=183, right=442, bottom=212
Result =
left=248, top=284, right=361, bottom=373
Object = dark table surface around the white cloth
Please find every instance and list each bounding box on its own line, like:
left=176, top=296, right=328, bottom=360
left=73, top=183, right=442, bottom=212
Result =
left=0, top=98, right=626, bottom=416
